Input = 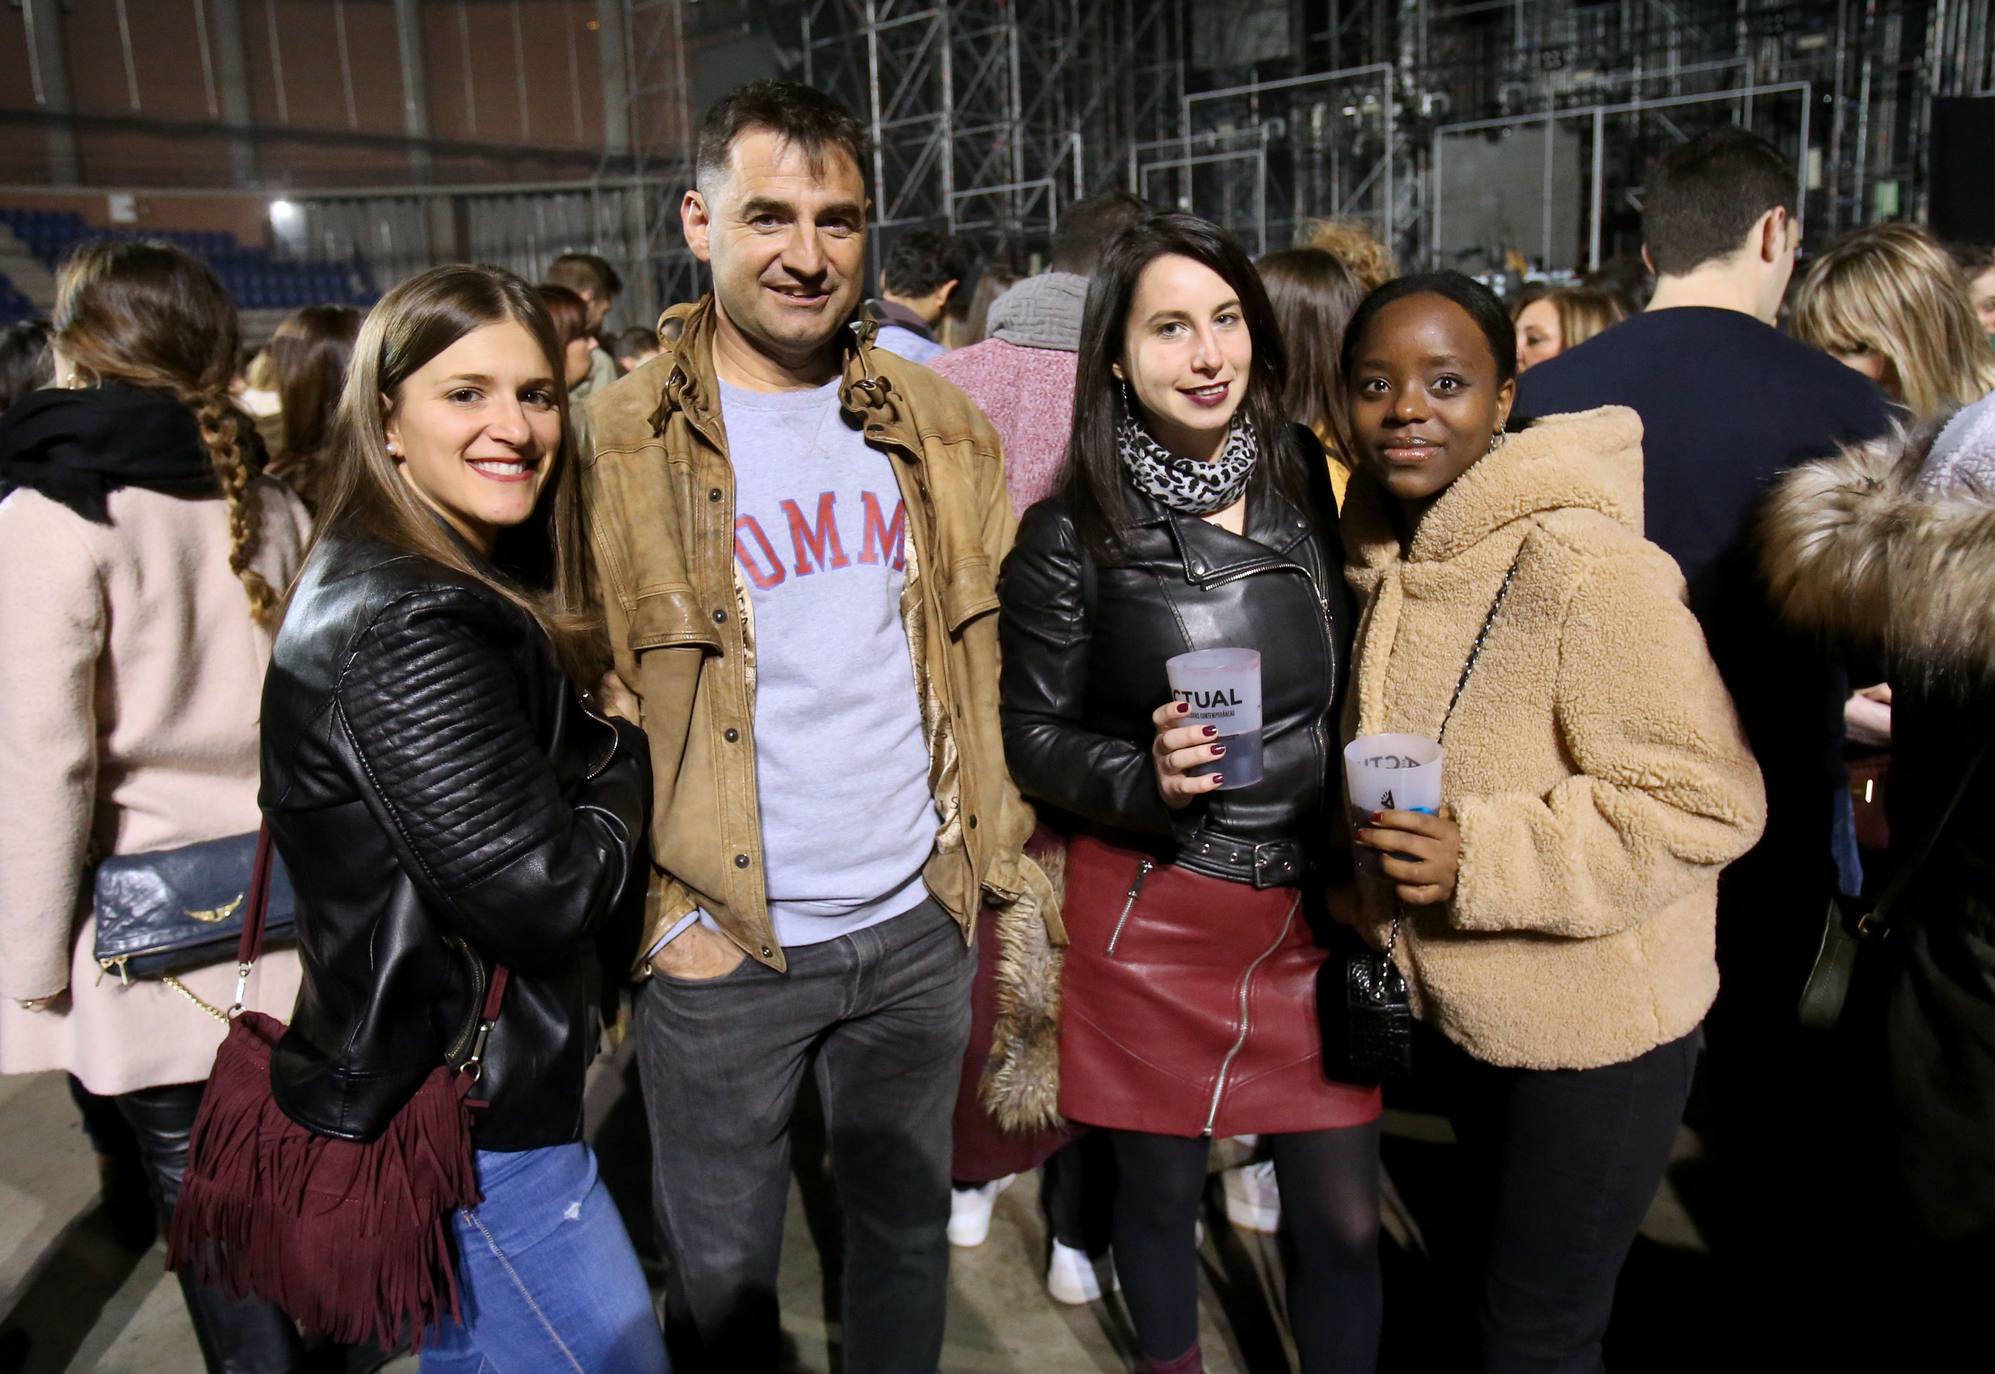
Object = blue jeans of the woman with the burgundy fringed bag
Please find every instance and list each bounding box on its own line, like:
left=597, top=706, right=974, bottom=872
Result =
left=423, top=1141, right=666, bottom=1374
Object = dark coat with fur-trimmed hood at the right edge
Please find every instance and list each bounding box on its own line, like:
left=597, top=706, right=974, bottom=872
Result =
left=1762, top=399, right=1995, bottom=1244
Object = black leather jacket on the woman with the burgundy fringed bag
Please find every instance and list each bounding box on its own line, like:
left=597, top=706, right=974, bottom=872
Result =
left=261, top=530, right=650, bottom=1151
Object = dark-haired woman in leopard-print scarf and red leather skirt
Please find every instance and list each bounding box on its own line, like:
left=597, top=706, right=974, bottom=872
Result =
left=999, top=215, right=1379, bottom=1374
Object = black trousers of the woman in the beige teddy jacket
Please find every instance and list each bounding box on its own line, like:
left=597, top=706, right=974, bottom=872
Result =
left=1420, top=1031, right=1700, bottom=1374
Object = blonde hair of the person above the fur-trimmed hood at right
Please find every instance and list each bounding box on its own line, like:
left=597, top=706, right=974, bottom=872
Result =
left=1794, top=223, right=1995, bottom=421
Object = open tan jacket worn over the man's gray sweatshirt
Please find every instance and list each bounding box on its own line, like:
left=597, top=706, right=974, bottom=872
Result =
left=583, top=297, right=1057, bottom=973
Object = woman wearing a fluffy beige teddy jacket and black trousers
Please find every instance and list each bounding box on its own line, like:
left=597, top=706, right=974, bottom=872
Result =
left=1345, top=273, right=1766, bottom=1372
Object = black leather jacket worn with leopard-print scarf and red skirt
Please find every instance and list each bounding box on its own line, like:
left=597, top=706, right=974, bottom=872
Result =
left=998, top=427, right=1353, bottom=885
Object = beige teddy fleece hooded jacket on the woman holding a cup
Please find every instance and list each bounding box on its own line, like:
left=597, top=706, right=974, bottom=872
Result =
left=1343, top=407, right=1766, bottom=1069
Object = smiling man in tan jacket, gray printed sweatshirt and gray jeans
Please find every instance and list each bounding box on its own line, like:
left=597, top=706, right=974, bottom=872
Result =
left=585, top=82, right=1057, bottom=1374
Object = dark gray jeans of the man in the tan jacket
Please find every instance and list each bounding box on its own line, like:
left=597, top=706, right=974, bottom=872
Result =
left=636, top=899, right=976, bottom=1374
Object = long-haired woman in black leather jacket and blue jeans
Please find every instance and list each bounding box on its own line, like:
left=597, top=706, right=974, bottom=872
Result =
left=261, top=267, right=666, bottom=1374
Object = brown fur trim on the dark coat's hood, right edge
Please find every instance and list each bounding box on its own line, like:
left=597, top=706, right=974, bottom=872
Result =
left=1762, top=429, right=1995, bottom=682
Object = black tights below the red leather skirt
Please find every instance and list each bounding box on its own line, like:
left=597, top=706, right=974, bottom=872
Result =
left=1109, top=1121, right=1383, bottom=1374
